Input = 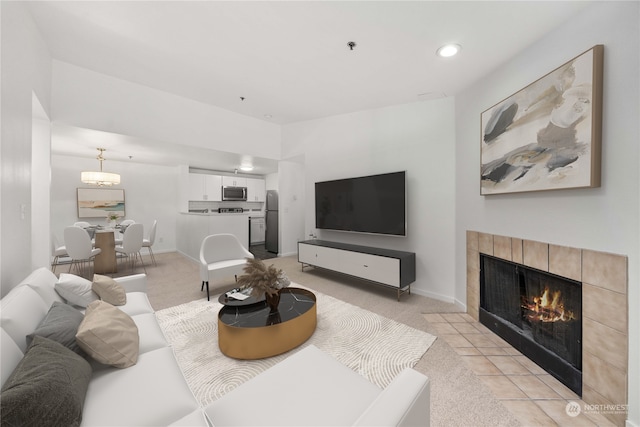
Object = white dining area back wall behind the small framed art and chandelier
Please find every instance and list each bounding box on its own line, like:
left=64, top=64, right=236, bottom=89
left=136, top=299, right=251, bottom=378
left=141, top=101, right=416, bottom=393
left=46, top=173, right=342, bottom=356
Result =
left=51, top=155, right=179, bottom=255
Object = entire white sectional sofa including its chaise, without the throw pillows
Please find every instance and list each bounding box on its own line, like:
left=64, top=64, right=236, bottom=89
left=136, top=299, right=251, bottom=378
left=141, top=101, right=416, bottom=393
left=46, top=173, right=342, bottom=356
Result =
left=0, top=268, right=429, bottom=427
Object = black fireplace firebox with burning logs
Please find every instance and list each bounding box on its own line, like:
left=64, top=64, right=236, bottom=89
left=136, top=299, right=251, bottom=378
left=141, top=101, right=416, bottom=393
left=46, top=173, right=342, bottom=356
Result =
left=479, top=254, right=582, bottom=396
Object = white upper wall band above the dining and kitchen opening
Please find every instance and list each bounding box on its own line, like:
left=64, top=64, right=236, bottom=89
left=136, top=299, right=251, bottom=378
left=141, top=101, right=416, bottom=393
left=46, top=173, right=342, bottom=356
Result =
left=51, top=60, right=280, bottom=159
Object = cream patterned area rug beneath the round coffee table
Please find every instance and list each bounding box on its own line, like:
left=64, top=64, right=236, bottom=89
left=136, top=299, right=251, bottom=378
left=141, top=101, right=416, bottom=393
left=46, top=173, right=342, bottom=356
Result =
left=156, top=285, right=436, bottom=405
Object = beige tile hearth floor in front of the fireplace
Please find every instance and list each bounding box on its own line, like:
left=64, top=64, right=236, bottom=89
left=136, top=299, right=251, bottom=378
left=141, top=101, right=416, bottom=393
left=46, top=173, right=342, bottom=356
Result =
left=424, top=313, right=614, bottom=426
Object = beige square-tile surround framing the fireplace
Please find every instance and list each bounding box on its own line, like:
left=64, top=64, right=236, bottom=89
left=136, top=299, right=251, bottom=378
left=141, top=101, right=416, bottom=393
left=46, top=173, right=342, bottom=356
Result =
left=467, top=231, right=629, bottom=425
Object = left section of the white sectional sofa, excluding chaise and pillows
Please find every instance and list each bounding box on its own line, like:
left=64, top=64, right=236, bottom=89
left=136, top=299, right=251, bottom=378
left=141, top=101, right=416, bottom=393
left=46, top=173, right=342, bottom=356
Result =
left=0, top=268, right=208, bottom=426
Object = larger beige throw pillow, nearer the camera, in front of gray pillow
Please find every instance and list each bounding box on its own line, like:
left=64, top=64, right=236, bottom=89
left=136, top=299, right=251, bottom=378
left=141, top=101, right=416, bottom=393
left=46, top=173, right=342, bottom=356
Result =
left=76, top=301, right=140, bottom=368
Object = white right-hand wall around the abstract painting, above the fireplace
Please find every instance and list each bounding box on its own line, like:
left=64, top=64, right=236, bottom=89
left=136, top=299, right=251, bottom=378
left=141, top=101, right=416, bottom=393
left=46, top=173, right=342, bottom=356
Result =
left=455, top=2, right=640, bottom=425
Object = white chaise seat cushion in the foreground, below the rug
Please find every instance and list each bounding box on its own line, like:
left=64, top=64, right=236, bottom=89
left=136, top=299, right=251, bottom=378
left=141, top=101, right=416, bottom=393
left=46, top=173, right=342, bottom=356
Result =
left=205, top=345, right=381, bottom=426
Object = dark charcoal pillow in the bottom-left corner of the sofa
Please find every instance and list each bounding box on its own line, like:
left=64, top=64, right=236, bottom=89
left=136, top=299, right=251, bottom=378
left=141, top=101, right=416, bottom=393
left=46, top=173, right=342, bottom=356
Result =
left=0, top=336, right=91, bottom=426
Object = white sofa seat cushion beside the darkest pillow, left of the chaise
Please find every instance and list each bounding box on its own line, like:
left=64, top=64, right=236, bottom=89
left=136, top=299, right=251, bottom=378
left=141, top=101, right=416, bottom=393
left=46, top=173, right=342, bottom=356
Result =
left=83, top=344, right=200, bottom=426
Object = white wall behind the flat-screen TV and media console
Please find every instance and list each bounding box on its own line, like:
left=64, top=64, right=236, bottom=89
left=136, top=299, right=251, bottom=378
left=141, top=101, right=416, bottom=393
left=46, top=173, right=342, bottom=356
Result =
left=280, top=99, right=455, bottom=302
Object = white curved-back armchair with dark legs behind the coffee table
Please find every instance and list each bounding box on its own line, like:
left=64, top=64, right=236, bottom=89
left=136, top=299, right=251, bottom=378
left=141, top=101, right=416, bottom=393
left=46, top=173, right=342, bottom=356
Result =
left=200, top=234, right=253, bottom=301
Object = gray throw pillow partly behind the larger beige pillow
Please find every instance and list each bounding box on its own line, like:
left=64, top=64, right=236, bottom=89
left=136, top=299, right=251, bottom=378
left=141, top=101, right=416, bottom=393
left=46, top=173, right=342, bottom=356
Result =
left=27, top=301, right=85, bottom=356
